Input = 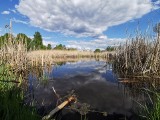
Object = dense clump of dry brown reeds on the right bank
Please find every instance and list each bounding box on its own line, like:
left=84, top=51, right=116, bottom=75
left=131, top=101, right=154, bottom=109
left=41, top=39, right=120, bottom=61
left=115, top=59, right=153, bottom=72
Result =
left=113, top=35, right=160, bottom=76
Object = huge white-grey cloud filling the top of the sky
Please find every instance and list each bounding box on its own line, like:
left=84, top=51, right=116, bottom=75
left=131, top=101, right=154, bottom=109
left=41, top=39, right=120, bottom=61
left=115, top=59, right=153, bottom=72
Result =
left=15, top=0, right=153, bottom=38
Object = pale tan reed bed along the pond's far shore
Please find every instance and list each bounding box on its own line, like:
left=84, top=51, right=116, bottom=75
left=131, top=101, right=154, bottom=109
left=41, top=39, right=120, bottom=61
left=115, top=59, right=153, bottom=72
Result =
left=27, top=50, right=115, bottom=66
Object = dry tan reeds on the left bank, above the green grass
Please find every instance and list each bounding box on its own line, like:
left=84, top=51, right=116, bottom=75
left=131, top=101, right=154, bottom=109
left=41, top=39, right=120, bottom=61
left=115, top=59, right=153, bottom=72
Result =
left=0, top=40, right=27, bottom=72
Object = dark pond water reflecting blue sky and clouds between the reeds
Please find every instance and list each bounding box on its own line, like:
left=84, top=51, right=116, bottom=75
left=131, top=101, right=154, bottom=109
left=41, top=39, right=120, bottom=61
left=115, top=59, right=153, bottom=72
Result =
left=26, top=60, right=138, bottom=119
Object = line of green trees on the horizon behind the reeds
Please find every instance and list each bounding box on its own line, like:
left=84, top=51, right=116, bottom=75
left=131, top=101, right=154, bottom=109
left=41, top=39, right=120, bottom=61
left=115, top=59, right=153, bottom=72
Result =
left=0, top=32, right=114, bottom=52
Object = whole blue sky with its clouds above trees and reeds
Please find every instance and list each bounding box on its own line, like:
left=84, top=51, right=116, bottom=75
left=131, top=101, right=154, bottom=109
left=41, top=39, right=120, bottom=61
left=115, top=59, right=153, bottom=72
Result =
left=0, top=0, right=160, bottom=50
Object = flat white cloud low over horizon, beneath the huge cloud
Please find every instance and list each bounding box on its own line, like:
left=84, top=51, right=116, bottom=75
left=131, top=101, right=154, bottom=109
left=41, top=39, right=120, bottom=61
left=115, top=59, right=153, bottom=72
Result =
left=66, top=38, right=126, bottom=50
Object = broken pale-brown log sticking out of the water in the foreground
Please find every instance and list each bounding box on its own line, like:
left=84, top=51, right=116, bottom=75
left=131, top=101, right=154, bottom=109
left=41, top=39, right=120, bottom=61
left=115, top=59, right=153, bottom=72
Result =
left=42, top=96, right=76, bottom=120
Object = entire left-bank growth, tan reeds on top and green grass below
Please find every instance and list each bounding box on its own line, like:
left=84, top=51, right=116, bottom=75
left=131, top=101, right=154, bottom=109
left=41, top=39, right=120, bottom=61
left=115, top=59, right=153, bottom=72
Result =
left=0, top=38, right=39, bottom=120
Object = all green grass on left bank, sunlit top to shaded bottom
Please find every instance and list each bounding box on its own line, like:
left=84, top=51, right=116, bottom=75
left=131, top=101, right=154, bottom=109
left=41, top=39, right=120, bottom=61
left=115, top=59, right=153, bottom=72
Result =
left=0, top=60, right=41, bottom=120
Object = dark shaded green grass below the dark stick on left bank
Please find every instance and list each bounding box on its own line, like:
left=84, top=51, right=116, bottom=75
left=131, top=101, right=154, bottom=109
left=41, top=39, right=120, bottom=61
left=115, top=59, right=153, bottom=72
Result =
left=0, top=88, right=40, bottom=120
